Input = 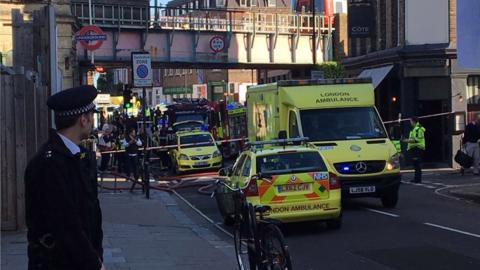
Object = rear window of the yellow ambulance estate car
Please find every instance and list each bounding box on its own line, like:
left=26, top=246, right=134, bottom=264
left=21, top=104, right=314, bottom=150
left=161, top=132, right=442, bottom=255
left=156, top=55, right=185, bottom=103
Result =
left=257, top=151, right=327, bottom=176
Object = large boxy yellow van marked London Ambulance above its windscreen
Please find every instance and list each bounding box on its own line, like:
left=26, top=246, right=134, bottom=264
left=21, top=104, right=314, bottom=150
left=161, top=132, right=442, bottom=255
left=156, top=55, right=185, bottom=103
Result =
left=247, top=79, right=400, bottom=207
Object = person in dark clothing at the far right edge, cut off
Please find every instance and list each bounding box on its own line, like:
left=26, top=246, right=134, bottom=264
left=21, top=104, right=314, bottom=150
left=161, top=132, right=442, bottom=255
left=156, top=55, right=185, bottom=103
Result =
left=462, top=114, right=480, bottom=175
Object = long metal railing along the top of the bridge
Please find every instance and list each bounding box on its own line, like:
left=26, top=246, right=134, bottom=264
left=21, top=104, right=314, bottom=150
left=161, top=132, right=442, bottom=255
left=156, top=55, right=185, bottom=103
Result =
left=72, top=3, right=333, bottom=35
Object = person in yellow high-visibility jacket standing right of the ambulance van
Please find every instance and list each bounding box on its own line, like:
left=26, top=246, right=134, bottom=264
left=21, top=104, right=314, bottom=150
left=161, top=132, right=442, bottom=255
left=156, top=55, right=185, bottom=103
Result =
left=403, top=117, right=425, bottom=183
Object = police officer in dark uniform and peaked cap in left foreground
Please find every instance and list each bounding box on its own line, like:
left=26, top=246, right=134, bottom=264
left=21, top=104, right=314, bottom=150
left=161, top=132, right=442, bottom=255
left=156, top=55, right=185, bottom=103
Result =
left=25, top=86, right=105, bottom=270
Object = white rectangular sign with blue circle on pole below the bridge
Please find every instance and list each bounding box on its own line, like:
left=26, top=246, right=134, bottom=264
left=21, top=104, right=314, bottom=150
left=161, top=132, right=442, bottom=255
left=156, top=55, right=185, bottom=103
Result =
left=132, top=52, right=152, bottom=87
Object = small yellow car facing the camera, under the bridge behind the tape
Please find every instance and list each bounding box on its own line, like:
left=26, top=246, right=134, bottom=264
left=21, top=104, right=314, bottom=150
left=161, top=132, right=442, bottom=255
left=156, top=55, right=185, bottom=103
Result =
left=170, top=130, right=222, bottom=173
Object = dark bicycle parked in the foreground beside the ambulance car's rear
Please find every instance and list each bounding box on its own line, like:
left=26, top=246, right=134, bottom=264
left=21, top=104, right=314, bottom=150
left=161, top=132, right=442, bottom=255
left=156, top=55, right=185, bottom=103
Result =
left=213, top=180, right=292, bottom=270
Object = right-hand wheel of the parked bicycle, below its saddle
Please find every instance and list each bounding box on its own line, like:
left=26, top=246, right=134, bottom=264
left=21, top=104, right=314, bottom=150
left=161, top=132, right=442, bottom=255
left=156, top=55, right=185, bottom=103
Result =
left=260, top=224, right=292, bottom=270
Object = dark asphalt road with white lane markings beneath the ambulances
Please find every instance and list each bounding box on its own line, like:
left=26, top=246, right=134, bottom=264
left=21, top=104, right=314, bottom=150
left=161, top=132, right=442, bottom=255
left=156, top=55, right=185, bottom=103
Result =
left=178, top=175, right=480, bottom=270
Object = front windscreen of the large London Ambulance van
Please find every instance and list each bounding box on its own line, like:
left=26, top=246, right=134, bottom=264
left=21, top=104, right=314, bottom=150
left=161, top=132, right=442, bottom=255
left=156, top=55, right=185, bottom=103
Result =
left=300, top=107, right=386, bottom=141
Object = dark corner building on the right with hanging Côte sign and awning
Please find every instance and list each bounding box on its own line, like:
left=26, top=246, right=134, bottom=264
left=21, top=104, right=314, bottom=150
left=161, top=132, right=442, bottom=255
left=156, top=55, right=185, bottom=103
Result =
left=343, top=0, right=480, bottom=167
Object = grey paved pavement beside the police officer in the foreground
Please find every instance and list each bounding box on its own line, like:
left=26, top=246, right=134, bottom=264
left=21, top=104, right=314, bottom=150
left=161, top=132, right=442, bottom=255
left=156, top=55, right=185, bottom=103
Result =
left=1, top=184, right=236, bottom=270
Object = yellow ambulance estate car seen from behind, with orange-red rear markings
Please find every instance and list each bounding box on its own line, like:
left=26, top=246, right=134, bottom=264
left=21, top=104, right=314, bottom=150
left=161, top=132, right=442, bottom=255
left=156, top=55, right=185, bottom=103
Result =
left=217, top=138, right=342, bottom=229
